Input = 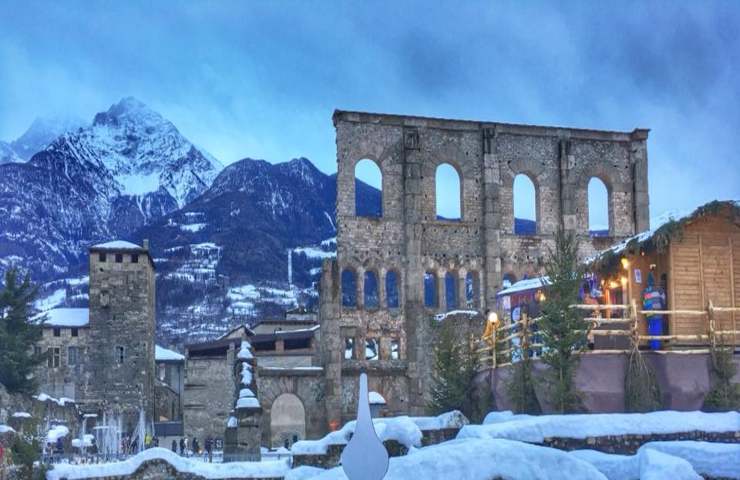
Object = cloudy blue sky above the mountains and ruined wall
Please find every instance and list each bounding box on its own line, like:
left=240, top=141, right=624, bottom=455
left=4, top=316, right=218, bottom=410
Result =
left=0, top=0, right=740, bottom=226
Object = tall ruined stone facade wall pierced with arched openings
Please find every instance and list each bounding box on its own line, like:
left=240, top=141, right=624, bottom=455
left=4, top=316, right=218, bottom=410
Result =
left=320, top=111, right=649, bottom=423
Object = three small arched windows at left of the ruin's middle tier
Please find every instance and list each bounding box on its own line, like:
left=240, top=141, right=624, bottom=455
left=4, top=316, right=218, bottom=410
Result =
left=341, top=268, right=401, bottom=309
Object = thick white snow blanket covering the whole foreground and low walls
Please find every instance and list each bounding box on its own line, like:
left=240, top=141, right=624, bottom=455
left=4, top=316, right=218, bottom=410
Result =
left=36, top=412, right=740, bottom=480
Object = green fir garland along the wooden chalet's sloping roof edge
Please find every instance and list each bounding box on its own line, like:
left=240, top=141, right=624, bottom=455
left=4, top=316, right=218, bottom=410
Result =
left=590, top=200, right=740, bottom=276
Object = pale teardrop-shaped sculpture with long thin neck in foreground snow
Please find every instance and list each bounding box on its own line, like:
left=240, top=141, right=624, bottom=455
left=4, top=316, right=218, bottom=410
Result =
left=342, top=373, right=388, bottom=480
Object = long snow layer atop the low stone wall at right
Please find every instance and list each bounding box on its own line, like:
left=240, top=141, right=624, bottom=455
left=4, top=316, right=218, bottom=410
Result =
left=457, top=410, right=740, bottom=443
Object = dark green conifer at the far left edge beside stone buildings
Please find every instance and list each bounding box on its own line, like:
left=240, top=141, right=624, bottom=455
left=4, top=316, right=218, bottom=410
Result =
left=0, top=269, right=44, bottom=393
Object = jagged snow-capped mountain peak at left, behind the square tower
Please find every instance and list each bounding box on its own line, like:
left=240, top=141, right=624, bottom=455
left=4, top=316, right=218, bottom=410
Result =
left=0, top=98, right=221, bottom=279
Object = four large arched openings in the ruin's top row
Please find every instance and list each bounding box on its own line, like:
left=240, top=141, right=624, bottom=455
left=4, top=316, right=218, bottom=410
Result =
left=355, top=159, right=610, bottom=236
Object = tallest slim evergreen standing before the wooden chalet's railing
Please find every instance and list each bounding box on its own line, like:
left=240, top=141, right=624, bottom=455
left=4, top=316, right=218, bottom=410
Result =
left=539, top=230, right=588, bottom=413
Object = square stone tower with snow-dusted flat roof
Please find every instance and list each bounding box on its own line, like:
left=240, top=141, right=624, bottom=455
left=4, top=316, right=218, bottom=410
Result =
left=86, top=240, right=156, bottom=433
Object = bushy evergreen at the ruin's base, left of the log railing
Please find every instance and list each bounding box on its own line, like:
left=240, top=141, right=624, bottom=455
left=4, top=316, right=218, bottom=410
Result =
left=429, top=321, right=479, bottom=418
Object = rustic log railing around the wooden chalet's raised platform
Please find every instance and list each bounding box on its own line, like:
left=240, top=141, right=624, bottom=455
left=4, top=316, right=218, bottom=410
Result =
left=475, top=300, right=740, bottom=369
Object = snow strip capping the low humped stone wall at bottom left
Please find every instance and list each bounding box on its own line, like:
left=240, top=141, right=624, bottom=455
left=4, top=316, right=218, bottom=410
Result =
left=46, top=448, right=290, bottom=480
